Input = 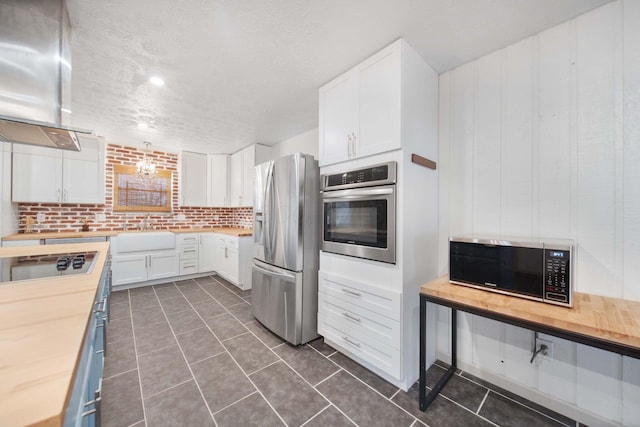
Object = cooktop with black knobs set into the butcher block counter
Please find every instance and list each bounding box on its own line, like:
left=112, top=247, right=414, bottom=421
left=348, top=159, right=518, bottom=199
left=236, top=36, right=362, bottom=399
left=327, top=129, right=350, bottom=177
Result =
left=0, top=252, right=96, bottom=282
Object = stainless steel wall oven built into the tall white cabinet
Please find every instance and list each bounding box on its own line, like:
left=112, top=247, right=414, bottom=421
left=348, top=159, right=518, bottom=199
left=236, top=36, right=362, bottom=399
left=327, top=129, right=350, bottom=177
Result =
left=321, top=162, right=396, bottom=264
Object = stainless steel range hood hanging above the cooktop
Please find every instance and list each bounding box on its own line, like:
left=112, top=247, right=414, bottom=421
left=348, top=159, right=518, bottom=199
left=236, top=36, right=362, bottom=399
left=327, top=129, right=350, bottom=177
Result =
left=0, top=0, right=93, bottom=151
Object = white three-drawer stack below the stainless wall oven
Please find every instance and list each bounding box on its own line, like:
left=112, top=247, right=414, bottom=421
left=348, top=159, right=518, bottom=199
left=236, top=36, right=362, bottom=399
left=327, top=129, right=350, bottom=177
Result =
left=318, top=271, right=402, bottom=378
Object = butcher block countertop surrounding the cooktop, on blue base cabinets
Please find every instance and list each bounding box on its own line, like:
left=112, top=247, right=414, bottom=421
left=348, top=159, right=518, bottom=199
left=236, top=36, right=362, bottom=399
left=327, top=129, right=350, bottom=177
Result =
left=0, top=242, right=109, bottom=426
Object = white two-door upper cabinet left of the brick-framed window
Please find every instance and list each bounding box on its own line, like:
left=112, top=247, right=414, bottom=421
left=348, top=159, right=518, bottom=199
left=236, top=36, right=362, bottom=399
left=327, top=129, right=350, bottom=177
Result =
left=11, top=138, right=105, bottom=204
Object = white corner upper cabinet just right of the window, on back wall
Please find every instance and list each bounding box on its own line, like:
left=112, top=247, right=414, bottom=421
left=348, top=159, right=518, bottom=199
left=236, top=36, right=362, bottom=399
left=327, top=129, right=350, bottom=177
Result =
left=179, top=151, right=229, bottom=207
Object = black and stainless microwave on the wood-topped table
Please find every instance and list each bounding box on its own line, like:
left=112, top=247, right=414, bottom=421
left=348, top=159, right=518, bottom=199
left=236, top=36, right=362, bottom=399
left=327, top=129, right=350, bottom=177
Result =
left=449, top=237, right=573, bottom=307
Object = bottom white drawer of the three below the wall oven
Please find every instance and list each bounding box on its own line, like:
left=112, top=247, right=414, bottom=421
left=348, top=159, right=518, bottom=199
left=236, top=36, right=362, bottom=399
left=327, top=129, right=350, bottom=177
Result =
left=318, top=313, right=401, bottom=379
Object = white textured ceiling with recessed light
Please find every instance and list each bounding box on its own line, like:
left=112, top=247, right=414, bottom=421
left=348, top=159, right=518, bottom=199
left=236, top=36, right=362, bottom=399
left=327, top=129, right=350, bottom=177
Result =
left=67, top=0, right=609, bottom=153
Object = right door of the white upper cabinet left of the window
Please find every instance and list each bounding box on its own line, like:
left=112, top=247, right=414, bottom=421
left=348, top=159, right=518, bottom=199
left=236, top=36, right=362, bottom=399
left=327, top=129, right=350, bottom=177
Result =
left=62, top=138, right=105, bottom=204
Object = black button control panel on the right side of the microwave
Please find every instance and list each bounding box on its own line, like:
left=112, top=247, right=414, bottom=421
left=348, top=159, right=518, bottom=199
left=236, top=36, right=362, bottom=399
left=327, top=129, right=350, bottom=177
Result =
left=544, top=249, right=571, bottom=303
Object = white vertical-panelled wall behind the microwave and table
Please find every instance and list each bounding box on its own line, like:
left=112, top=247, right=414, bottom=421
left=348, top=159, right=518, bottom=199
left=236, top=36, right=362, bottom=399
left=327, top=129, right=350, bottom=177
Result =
left=437, top=0, right=640, bottom=426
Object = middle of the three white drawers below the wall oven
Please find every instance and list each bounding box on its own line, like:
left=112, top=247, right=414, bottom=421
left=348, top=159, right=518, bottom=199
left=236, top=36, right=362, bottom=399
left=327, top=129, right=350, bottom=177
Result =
left=318, top=293, right=400, bottom=349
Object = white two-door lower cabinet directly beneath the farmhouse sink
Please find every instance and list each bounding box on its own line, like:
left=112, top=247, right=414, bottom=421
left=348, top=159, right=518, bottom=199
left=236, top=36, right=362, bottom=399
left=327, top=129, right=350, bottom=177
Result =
left=112, top=251, right=180, bottom=286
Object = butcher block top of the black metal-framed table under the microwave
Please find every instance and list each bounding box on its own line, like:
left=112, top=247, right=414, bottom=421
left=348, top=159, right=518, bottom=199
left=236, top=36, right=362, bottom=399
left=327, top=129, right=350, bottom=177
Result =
left=420, top=276, right=640, bottom=353
